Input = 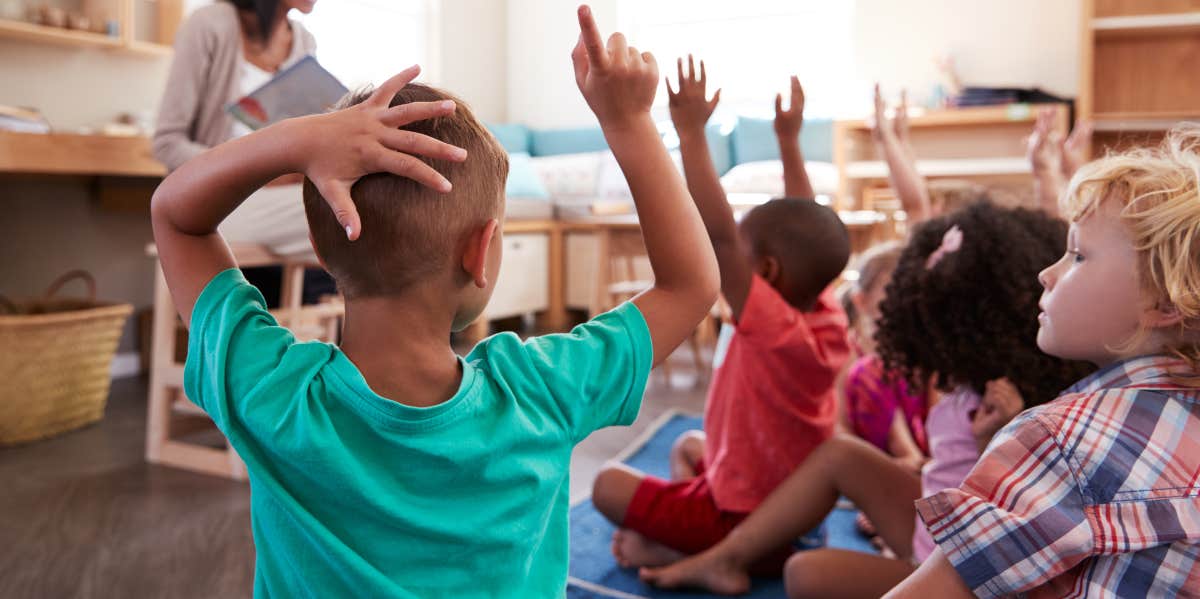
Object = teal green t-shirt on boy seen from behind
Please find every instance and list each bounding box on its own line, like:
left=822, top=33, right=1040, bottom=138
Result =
left=184, top=269, right=653, bottom=598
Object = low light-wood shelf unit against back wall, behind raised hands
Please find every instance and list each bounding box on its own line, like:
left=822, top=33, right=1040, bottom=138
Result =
left=833, top=103, right=1069, bottom=210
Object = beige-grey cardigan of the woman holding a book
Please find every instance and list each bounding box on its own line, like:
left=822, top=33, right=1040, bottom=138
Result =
left=154, top=0, right=317, bottom=170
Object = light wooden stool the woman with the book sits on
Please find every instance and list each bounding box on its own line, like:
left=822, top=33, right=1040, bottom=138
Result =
left=146, top=244, right=344, bottom=480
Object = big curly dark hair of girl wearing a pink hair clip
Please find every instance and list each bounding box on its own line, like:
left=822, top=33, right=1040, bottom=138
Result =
left=875, top=200, right=1094, bottom=407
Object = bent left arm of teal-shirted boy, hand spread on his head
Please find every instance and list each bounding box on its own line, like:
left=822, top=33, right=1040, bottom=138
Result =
left=150, top=66, right=466, bottom=324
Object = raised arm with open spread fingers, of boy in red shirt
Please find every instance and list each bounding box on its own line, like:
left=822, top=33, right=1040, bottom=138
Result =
left=667, top=54, right=754, bottom=319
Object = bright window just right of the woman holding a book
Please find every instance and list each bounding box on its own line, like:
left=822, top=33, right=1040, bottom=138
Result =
left=298, top=0, right=438, bottom=89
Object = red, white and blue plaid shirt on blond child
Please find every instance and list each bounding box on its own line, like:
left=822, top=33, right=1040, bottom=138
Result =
left=917, top=357, right=1200, bottom=598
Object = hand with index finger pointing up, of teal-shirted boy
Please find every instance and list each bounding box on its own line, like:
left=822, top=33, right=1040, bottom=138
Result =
left=571, top=5, right=659, bottom=127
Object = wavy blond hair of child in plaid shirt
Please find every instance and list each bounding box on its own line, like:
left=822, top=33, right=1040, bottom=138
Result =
left=1060, top=124, right=1200, bottom=372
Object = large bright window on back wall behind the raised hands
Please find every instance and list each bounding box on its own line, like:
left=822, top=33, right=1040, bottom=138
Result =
left=618, top=0, right=862, bottom=116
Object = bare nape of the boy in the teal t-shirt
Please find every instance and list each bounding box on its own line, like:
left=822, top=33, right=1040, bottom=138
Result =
left=341, top=289, right=462, bottom=407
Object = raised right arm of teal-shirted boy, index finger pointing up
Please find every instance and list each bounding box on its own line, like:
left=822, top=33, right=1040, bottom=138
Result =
left=571, top=6, right=720, bottom=364
